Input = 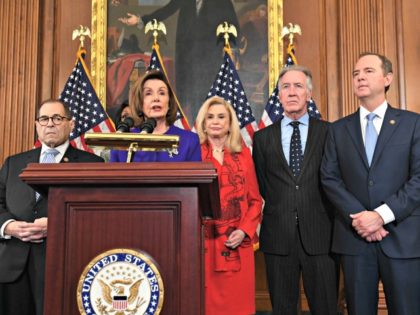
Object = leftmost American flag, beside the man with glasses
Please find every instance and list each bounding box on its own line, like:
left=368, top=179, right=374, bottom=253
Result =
left=60, top=48, right=115, bottom=152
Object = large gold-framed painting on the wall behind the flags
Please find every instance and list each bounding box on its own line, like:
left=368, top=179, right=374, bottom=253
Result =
left=91, top=0, right=283, bottom=125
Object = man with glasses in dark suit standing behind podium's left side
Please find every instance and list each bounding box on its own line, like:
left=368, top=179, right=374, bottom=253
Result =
left=0, top=100, right=103, bottom=315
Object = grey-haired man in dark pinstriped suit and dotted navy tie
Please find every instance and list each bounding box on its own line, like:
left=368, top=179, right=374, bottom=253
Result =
left=253, top=66, right=338, bottom=315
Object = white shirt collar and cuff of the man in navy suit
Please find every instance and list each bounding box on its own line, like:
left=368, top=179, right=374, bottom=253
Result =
left=359, top=100, right=395, bottom=225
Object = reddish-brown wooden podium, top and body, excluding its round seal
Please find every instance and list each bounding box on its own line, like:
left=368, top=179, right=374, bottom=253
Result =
left=21, top=162, right=220, bottom=315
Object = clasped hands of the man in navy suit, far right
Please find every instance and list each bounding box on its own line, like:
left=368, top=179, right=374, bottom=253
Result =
left=350, top=210, right=389, bottom=242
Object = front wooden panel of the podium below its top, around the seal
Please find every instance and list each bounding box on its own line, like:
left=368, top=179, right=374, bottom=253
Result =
left=45, top=185, right=203, bottom=315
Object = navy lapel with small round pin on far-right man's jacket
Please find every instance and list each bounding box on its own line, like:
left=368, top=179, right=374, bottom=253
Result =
left=371, top=104, right=401, bottom=166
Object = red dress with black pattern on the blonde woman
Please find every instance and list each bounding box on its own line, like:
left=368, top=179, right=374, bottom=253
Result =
left=201, top=144, right=262, bottom=315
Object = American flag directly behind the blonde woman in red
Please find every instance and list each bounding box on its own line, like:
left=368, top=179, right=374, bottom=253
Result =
left=207, top=52, right=258, bottom=147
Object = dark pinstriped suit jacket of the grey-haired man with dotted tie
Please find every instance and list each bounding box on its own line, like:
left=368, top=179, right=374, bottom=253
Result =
left=253, top=118, right=333, bottom=255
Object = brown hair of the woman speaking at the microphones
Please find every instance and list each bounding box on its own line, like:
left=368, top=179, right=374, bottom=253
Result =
left=129, top=70, right=178, bottom=126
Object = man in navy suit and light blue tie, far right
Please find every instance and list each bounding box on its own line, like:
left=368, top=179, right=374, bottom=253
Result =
left=321, top=53, right=420, bottom=315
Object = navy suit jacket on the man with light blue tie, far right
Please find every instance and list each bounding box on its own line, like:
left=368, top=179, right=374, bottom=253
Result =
left=321, top=106, right=420, bottom=258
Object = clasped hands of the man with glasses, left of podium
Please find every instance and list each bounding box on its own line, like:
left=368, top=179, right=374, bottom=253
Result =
left=4, top=218, right=48, bottom=243
